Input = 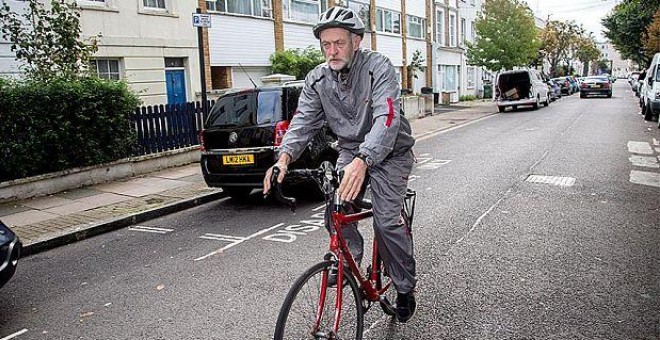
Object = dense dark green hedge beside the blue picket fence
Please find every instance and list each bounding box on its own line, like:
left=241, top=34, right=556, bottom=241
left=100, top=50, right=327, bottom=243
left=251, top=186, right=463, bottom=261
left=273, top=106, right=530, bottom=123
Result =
left=0, top=78, right=140, bottom=182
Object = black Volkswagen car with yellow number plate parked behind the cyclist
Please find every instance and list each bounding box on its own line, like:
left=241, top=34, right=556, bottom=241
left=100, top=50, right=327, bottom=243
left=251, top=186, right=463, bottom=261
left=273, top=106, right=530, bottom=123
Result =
left=200, top=82, right=338, bottom=198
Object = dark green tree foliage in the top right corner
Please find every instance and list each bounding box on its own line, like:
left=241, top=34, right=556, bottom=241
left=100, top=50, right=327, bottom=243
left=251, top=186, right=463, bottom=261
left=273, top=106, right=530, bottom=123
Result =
left=601, top=0, right=660, bottom=66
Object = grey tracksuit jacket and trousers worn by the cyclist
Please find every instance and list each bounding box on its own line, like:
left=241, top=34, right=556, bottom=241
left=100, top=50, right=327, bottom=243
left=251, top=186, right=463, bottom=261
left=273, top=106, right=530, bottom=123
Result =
left=280, top=49, right=416, bottom=293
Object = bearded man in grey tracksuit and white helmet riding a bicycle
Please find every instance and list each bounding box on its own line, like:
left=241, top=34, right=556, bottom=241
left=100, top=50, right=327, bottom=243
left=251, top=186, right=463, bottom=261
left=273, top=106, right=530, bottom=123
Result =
left=264, top=6, right=417, bottom=322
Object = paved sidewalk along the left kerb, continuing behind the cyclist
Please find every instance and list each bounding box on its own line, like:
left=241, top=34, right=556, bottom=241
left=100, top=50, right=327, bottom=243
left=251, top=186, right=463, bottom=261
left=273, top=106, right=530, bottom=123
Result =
left=0, top=100, right=497, bottom=256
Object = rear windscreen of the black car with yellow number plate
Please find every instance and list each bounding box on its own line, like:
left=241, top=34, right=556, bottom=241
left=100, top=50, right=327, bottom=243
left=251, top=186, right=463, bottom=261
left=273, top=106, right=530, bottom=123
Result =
left=206, top=90, right=282, bottom=127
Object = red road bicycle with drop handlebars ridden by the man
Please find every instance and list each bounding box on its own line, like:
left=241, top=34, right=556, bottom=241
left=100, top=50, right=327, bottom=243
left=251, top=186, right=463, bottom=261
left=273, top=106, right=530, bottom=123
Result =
left=272, top=162, right=416, bottom=340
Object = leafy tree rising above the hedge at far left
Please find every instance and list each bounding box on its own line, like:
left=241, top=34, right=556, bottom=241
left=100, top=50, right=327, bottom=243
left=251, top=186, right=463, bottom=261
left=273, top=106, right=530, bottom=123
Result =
left=0, top=0, right=97, bottom=80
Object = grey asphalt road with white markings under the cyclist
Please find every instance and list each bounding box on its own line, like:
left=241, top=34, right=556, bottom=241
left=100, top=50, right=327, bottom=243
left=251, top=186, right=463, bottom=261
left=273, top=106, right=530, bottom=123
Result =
left=0, top=81, right=660, bottom=340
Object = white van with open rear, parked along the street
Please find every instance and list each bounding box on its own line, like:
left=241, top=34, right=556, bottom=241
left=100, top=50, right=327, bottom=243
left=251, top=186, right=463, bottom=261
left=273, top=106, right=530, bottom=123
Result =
left=493, top=69, right=551, bottom=112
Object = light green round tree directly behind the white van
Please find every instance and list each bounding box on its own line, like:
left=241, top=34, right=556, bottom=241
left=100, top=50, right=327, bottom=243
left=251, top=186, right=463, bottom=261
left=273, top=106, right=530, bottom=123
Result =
left=466, top=0, right=540, bottom=71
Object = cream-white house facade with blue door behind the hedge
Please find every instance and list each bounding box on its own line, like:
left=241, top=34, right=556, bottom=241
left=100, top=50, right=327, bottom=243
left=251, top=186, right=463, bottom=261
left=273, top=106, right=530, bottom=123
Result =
left=0, top=0, right=201, bottom=105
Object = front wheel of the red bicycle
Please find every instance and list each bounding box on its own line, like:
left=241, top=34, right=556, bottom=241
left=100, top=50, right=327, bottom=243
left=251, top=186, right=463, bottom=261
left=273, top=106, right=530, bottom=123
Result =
left=274, top=261, right=364, bottom=340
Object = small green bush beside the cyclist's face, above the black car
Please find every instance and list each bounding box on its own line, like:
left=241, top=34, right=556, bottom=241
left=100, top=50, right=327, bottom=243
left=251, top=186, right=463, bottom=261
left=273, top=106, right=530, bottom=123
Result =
left=270, top=46, right=325, bottom=79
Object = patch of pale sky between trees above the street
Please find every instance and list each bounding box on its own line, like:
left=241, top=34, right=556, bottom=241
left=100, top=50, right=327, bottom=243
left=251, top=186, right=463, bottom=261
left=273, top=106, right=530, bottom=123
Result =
left=523, top=0, right=621, bottom=41
